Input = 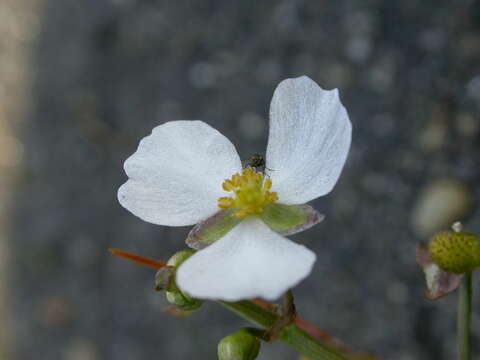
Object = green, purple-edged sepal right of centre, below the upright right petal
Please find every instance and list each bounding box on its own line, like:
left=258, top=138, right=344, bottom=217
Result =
left=260, top=204, right=325, bottom=236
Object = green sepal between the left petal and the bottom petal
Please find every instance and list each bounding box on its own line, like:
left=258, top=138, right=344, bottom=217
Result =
left=185, top=209, right=242, bottom=250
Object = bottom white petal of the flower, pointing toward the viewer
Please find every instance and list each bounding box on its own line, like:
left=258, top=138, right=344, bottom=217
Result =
left=177, top=218, right=315, bottom=301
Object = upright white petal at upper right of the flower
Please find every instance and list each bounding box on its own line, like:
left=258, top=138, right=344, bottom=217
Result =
left=266, top=76, right=352, bottom=204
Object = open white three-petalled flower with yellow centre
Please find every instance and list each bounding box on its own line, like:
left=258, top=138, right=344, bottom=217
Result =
left=118, top=76, right=351, bottom=301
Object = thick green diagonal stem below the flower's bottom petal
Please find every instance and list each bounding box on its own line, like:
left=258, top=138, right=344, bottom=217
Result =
left=219, top=301, right=346, bottom=360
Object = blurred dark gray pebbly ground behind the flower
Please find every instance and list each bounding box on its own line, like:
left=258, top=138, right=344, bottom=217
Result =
left=0, top=0, right=480, bottom=360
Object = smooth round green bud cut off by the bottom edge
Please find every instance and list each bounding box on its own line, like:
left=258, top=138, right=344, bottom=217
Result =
left=218, top=329, right=260, bottom=360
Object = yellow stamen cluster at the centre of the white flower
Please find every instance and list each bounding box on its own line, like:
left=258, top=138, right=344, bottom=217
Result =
left=218, top=168, right=278, bottom=218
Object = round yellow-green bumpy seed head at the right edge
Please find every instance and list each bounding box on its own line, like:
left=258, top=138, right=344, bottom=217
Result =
left=428, top=231, right=480, bottom=274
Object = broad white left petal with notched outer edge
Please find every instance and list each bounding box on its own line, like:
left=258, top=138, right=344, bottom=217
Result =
left=118, top=121, right=242, bottom=226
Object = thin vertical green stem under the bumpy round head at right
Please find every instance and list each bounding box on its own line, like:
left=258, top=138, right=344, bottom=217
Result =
left=457, top=272, right=472, bottom=360
